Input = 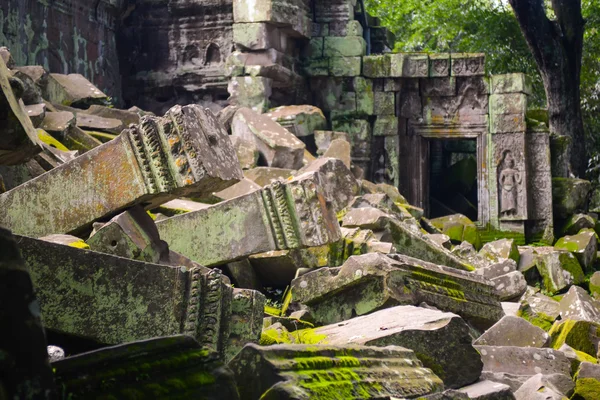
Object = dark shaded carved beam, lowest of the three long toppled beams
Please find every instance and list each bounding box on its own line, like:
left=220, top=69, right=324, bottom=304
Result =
left=18, top=236, right=264, bottom=358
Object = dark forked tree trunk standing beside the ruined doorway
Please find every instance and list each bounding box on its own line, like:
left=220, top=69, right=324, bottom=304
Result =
left=509, top=0, right=587, bottom=176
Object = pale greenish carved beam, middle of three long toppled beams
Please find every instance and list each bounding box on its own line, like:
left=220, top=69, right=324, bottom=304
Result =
left=156, top=173, right=341, bottom=266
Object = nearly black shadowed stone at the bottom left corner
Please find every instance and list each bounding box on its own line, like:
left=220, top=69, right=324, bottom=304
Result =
left=0, top=227, right=54, bottom=399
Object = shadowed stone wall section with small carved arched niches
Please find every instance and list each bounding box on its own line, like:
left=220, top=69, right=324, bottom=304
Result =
left=119, top=0, right=233, bottom=114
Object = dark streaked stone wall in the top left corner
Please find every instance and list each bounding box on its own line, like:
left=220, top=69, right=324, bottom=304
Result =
left=0, top=0, right=121, bottom=100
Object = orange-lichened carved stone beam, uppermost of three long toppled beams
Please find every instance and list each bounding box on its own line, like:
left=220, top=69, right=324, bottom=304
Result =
left=0, top=105, right=242, bottom=237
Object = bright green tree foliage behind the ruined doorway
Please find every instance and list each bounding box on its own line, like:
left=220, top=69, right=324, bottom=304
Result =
left=365, top=0, right=600, bottom=150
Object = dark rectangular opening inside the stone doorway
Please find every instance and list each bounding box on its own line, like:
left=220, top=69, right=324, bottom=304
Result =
left=429, top=139, right=478, bottom=221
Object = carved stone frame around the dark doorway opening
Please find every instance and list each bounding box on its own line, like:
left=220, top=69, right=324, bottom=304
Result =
left=401, top=121, right=495, bottom=228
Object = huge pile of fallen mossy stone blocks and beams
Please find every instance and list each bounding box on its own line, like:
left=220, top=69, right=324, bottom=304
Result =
left=0, top=47, right=600, bottom=400
